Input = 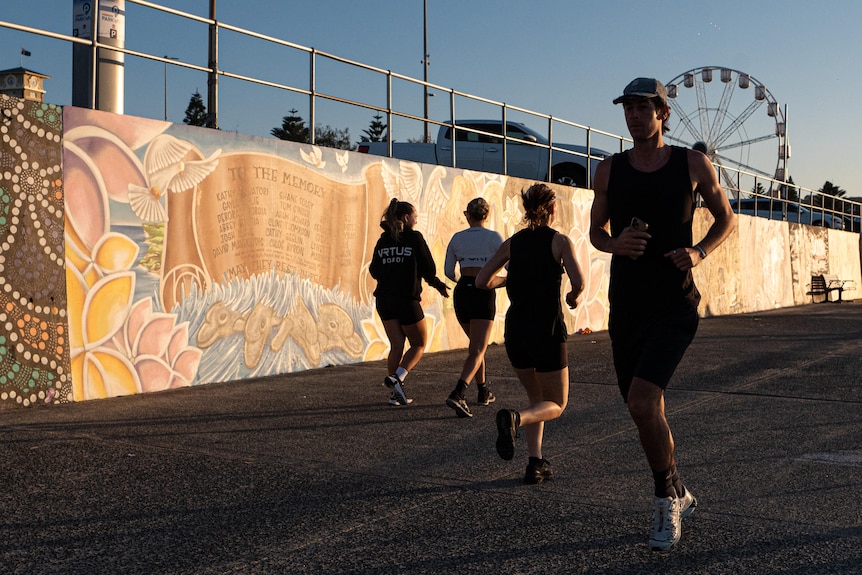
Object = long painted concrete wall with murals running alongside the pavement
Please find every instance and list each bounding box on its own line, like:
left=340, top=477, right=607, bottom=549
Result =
left=0, top=97, right=860, bottom=407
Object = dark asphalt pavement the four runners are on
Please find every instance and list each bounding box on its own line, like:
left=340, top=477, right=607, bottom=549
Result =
left=0, top=303, right=862, bottom=575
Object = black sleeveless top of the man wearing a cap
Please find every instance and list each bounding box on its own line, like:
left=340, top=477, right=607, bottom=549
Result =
left=607, top=146, right=700, bottom=318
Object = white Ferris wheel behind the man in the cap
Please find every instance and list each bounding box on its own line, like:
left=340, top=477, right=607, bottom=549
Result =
left=665, top=66, right=790, bottom=194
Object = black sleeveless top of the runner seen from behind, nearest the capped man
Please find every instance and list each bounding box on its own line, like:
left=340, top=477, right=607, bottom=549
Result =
left=505, top=226, right=567, bottom=342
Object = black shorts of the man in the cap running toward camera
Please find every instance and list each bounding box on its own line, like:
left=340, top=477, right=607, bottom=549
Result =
left=608, top=308, right=699, bottom=400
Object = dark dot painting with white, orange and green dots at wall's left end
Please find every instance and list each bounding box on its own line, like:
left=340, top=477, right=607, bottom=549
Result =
left=0, top=95, right=72, bottom=409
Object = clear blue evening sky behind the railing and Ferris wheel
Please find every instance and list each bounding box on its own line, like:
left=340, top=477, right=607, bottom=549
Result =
left=5, top=0, right=862, bottom=197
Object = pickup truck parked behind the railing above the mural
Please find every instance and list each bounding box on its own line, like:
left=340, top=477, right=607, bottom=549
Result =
left=356, top=120, right=610, bottom=188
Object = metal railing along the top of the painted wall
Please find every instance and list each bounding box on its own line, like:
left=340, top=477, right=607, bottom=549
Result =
left=0, top=0, right=862, bottom=227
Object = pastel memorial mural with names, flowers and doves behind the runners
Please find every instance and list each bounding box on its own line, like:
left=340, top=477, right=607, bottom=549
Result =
left=55, top=108, right=607, bottom=408
